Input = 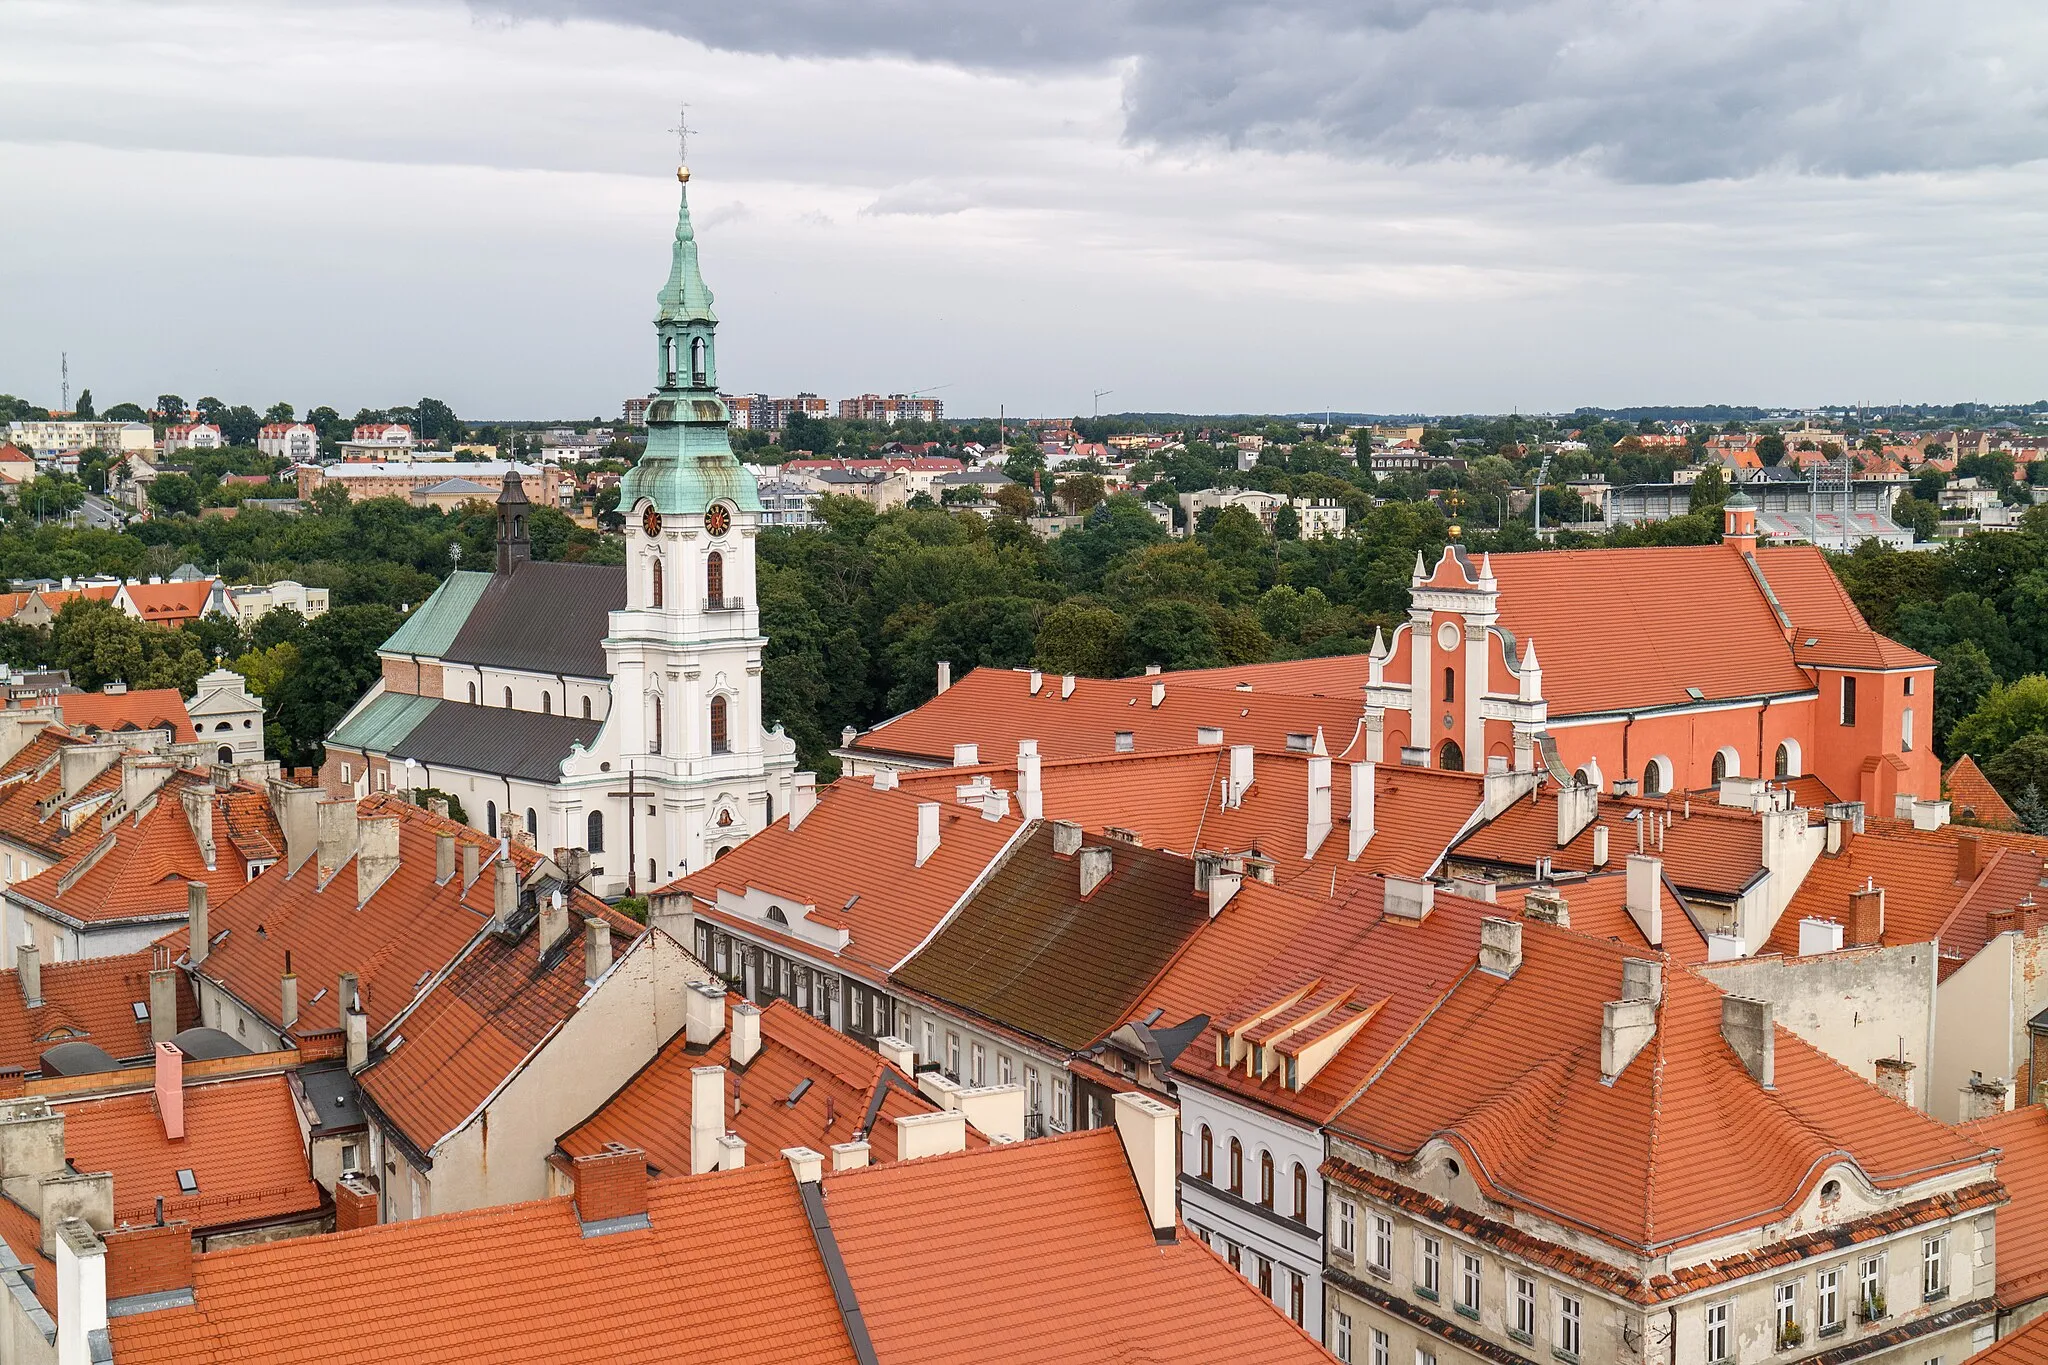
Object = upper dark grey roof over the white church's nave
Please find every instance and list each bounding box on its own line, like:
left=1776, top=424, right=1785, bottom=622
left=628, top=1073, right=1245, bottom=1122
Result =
left=436, top=559, right=627, bottom=677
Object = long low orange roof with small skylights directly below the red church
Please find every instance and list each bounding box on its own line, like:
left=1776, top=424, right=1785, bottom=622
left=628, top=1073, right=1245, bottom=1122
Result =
left=1450, top=786, right=1763, bottom=896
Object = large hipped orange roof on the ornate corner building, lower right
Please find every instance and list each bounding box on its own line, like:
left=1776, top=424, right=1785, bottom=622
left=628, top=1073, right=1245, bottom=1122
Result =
left=1331, top=921, right=1991, bottom=1257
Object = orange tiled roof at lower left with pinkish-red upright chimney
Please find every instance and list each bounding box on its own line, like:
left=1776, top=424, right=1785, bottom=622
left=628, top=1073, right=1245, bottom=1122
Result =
left=51, top=1074, right=324, bottom=1232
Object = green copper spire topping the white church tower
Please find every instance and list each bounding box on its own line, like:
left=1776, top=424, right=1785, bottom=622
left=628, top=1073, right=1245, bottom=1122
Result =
left=618, top=168, right=762, bottom=516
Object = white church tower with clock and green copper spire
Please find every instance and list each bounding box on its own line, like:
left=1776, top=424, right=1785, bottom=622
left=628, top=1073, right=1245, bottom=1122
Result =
left=565, top=168, right=797, bottom=890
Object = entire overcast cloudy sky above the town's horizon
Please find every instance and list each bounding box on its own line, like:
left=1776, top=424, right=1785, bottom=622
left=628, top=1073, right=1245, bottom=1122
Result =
left=0, top=0, right=2048, bottom=417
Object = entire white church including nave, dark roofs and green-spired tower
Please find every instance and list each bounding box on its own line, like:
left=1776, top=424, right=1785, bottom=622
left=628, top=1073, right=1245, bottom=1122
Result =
left=322, top=170, right=797, bottom=896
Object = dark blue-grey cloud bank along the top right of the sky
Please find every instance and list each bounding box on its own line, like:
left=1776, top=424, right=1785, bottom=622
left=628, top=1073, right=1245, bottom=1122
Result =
left=475, top=0, right=2048, bottom=182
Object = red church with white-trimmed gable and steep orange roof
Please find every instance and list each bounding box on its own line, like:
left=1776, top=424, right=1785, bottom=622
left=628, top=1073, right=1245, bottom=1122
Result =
left=1366, top=493, right=1942, bottom=817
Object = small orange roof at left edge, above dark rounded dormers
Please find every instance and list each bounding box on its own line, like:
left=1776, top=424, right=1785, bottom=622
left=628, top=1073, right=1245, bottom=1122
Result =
left=0, top=952, right=199, bottom=1074
